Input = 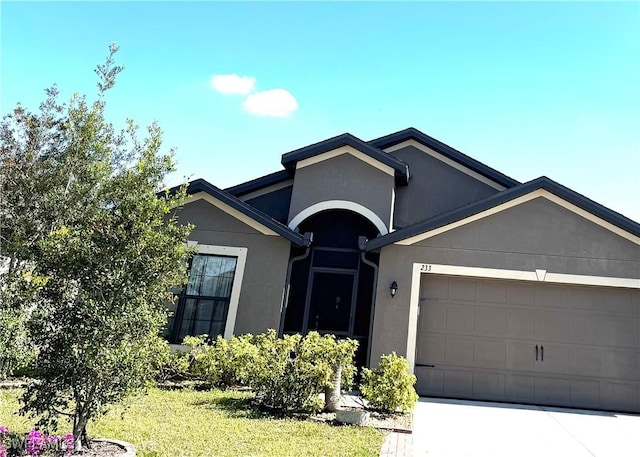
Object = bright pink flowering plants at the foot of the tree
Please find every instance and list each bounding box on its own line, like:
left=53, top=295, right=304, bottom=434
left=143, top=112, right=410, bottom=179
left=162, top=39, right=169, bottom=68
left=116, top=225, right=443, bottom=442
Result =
left=0, top=425, right=74, bottom=457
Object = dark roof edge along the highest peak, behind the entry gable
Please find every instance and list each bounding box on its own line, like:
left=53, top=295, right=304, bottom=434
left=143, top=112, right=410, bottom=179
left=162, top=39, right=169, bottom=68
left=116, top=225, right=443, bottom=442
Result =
left=368, top=127, right=520, bottom=189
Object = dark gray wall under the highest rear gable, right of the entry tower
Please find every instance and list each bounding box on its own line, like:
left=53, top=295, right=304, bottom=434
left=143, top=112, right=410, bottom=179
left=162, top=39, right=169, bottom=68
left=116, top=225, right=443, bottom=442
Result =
left=392, top=146, right=498, bottom=228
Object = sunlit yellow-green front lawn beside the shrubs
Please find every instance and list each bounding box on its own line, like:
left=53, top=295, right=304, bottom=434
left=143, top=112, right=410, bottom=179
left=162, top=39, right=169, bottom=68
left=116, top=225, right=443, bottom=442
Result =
left=0, top=389, right=383, bottom=457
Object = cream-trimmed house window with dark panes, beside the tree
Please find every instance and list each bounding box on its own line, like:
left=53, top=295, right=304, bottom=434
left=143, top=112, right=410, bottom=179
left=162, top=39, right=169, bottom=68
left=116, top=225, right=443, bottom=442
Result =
left=167, top=245, right=247, bottom=343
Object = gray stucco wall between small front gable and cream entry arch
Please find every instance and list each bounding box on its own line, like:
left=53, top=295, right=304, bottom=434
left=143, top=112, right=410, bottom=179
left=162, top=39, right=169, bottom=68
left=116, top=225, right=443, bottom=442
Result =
left=289, top=154, right=394, bottom=232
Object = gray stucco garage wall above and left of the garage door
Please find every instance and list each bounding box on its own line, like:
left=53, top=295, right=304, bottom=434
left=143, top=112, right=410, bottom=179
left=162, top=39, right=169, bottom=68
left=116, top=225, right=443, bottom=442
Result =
left=371, top=198, right=640, bottom=363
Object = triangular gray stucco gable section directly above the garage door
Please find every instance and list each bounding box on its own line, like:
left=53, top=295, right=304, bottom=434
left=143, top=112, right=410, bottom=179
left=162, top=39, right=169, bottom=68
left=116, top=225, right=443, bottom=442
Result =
left=413, top=198, right=640, bottom=278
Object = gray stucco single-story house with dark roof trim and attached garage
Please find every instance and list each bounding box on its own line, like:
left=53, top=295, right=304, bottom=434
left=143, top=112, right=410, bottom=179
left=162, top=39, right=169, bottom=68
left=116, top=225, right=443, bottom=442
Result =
left=169, top=128, right=640, bottom=412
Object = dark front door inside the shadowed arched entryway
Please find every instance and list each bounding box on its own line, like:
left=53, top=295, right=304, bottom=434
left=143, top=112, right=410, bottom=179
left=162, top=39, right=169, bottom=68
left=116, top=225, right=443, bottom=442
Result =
left=307, top=271, right=356, bottom=336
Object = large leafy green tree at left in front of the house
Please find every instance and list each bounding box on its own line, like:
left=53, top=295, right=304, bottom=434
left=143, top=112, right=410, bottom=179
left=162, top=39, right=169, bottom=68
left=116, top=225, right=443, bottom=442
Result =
left=0, top=44, right=190, bottom=449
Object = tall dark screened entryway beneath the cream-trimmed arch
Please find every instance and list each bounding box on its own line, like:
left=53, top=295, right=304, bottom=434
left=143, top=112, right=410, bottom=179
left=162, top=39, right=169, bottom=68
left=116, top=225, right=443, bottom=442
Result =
left=282, top=209, right=379, bottom=365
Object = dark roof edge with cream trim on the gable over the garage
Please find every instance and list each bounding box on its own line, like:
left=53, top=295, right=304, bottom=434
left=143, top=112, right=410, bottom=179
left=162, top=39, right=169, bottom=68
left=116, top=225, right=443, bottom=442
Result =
left=366, top=176, right=640, bottom=251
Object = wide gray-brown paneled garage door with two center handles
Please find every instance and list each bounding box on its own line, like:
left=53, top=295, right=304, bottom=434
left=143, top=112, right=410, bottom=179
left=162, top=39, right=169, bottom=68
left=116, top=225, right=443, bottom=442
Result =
left=416, top=274, right=640, bottom=412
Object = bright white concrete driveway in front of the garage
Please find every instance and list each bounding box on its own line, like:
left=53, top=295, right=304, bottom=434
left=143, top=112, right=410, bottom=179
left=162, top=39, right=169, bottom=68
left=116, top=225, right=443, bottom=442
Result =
left=413, top=398, right=640, bottom=457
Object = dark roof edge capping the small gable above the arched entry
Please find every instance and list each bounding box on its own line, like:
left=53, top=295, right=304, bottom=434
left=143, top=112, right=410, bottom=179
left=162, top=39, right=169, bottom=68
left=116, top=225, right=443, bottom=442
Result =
left=282, top=133, right=409, bottom=184
